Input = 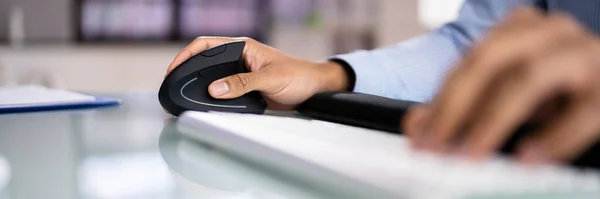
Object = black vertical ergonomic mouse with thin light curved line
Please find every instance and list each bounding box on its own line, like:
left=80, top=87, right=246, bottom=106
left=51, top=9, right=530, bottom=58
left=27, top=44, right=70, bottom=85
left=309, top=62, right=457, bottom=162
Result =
left=158, top=41, right=266, bottom=116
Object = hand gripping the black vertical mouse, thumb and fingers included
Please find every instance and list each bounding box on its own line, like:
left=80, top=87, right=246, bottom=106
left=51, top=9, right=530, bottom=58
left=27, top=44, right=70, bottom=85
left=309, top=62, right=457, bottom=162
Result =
left=167, top=37, right=348, bottom=110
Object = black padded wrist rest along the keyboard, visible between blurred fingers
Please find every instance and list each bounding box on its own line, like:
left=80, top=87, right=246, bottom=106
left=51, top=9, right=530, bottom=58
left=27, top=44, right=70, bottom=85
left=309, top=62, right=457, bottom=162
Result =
left=297, top=92, right=600, bottom=169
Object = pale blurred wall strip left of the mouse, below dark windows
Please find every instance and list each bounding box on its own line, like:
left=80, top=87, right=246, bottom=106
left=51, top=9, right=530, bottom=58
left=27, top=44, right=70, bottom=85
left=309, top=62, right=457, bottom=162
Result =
left=0, top=45, right=183, bottom=92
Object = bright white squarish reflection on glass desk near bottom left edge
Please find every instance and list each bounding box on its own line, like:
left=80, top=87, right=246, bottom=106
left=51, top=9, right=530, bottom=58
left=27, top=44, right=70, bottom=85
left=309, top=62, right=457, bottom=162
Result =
left=79, top=153, right=175, bottom=198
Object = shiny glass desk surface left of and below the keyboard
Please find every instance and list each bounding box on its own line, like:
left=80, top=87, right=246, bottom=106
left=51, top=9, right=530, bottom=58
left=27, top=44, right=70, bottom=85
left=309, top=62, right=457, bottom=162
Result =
left=0, top=93, right=380, bottom=199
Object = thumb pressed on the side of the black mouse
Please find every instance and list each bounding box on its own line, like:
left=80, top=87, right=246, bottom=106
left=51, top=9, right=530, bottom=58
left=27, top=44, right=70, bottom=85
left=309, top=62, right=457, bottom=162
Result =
left=208, top=72, right=264, bottom=99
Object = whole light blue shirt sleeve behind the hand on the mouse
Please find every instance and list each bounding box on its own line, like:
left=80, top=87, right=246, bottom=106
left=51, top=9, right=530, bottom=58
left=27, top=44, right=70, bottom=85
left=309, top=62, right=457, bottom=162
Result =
left=334, top=0, right=531, bottom=102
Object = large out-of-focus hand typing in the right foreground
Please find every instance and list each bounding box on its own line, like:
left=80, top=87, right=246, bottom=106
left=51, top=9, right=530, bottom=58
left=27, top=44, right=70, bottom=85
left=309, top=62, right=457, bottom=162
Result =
left=404, top=7, right=600, bottom=163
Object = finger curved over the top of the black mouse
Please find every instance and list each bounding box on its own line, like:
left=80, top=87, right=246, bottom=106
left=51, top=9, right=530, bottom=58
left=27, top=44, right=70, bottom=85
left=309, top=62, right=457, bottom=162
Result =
left=167, top=37, right=244, bottom=74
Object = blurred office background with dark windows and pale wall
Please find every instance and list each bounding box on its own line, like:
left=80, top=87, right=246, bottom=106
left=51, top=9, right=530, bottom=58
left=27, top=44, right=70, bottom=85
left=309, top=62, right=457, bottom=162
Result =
left=0, top=0, right=464, bottom=93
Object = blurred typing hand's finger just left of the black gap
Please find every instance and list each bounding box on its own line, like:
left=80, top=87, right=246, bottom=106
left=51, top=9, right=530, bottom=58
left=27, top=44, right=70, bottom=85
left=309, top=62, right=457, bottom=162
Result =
left=461, top=41, right=593, bottom=160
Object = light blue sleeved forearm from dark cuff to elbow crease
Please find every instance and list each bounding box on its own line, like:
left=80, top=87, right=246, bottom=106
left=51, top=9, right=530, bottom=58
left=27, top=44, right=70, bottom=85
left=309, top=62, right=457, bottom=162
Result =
left=336, top=33, right=460, bottom=102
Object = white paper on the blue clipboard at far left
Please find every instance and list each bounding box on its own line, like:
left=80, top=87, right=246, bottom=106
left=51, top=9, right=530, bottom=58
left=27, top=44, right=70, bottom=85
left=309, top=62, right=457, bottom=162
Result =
left=0, top=86, right=95, bottom=108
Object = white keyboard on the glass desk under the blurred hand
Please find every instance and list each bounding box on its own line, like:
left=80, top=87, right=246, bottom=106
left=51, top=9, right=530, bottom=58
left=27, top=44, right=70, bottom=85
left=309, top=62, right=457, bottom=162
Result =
left=178, top=112, right=600, bottom=199
